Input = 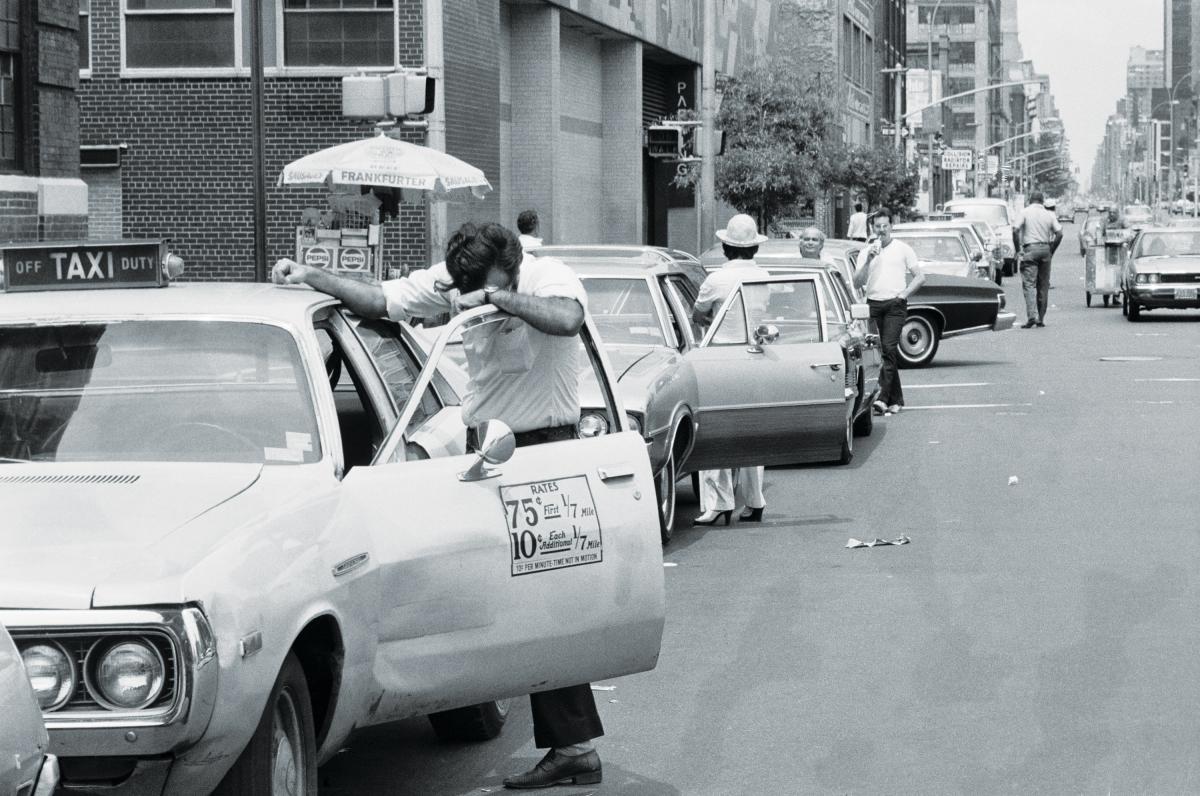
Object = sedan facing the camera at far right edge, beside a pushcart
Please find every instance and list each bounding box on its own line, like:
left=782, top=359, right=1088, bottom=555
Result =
left=1121, top=226, right=1200, bottom=322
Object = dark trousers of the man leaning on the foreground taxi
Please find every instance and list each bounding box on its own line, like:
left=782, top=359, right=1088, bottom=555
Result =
left=467, top=426, right=604, bottom=749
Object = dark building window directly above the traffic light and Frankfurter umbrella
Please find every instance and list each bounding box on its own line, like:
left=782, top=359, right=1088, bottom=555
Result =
left=283, top=0, right=396, bottom=66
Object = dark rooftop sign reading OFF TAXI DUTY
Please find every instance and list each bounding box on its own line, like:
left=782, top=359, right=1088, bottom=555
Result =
left=0, top=240, right=167, bottom=293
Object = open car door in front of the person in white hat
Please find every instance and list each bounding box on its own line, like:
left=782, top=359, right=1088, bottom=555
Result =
left=686, top=274, right=853, bottom=469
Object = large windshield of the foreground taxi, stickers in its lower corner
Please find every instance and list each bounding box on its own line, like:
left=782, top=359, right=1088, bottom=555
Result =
left=0, top=321, right=320, bottom=465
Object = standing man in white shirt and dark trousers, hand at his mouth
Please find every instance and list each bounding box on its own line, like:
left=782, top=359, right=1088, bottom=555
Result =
left=854, top=208, right=925, bottom=414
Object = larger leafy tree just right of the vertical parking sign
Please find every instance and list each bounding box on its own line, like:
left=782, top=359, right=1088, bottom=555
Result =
left=677, top=60, right=833, bottom=229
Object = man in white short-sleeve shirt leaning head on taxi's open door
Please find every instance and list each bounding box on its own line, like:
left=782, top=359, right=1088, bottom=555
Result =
left=271, top=223, right=604, bottom=788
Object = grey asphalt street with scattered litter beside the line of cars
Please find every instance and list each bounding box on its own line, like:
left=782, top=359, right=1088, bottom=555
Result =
left=320, top=225, right=1200, bottom=796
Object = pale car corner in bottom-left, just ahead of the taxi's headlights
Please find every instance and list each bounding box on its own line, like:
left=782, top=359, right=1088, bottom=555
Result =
left=0, top=624, right=59, bottom=796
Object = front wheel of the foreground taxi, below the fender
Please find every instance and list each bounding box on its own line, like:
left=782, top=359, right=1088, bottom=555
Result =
left=214, top=652, right=317, bottom=796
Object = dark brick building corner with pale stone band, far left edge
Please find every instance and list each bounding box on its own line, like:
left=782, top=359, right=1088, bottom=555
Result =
left=0, top=0, right=88, bottom=241
